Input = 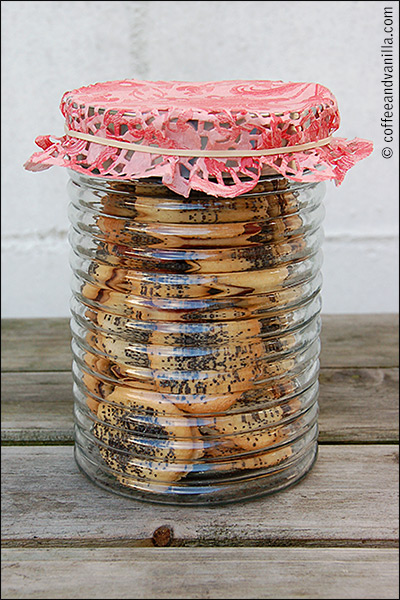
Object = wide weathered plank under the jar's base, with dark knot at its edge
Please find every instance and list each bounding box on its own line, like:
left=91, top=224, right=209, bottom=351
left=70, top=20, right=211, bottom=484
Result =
left=2, top=445, right=398, bottom=546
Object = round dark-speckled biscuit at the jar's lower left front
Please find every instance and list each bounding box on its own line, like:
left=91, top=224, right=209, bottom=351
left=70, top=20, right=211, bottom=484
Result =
left=93, top=386, right=203, bottom=482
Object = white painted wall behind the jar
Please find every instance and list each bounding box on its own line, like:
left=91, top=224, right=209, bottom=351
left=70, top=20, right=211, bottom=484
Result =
left=2, top=0, right=399, bottom=317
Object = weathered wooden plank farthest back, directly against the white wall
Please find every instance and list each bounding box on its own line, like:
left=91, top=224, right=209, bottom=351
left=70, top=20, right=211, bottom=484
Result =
left=2, top=314, right=399, bottom=371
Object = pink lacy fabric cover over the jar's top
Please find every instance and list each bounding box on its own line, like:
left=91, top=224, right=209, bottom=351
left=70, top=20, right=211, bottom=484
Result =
left=24, top=80, right=373, bottom=198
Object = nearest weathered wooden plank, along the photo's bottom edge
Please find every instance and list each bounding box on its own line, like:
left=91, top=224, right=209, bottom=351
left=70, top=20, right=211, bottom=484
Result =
left=2, top=548, right=398, bottom=599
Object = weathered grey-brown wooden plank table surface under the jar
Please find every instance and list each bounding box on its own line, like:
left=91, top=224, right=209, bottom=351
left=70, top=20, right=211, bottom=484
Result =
left=2, top=315, right=399, bottom=599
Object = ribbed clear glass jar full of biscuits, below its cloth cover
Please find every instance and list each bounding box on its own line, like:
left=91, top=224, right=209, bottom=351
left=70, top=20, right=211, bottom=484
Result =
left=69, top=171, right=325, bottom=505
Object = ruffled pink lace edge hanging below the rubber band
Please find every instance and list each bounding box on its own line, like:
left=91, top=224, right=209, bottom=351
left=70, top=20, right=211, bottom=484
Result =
left=24, top=135, right=373, bottom=198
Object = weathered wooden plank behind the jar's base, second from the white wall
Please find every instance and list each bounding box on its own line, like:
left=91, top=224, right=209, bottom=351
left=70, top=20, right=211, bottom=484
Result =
left=1, top=369, right=398, bottom=443
